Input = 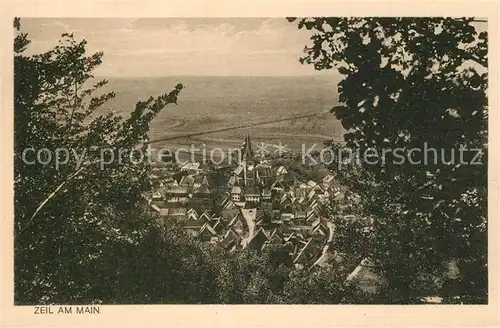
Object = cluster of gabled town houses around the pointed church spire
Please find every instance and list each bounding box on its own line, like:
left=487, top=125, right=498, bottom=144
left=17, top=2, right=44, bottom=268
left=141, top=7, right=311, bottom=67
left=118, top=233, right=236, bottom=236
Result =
left=145, top=136, right=348, bottom=266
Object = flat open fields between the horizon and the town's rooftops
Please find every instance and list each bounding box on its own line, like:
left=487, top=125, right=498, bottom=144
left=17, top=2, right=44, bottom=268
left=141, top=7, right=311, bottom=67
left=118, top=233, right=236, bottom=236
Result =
left=98, top=76, right=343, bottom=150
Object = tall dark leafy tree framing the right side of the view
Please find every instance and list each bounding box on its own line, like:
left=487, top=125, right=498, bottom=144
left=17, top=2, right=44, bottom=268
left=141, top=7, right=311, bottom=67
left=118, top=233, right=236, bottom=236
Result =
left=289, top=17, right=488, bottom=303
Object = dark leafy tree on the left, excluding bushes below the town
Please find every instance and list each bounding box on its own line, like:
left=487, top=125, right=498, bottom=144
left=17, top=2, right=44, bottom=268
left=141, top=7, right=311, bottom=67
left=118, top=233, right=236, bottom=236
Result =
left=14, top=19, right=182, bottom=303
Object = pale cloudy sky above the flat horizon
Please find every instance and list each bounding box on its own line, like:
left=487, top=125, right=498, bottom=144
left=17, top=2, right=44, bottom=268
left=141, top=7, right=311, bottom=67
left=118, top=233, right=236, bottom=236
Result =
left=21, top=18, right=329, bottom=77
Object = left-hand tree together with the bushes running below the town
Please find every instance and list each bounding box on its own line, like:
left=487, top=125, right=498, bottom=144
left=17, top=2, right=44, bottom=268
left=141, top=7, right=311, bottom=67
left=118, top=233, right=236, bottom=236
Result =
left=14, top=19, right=366, bottom=304
